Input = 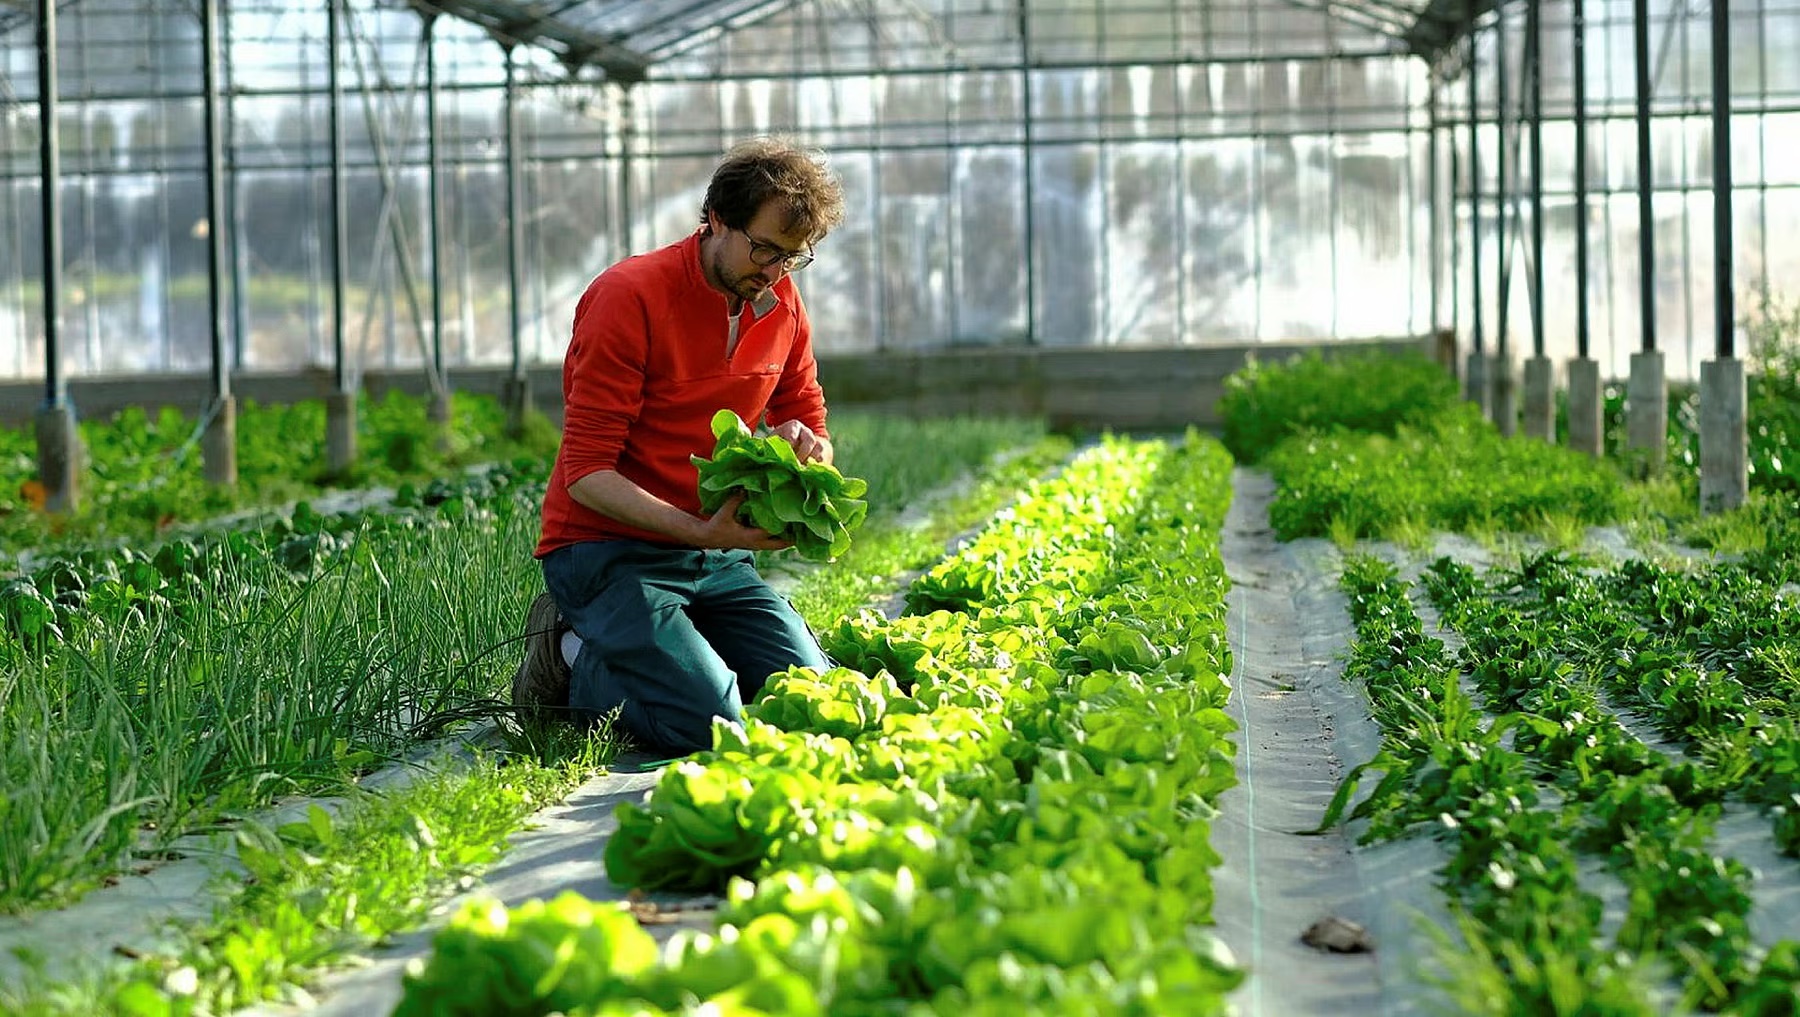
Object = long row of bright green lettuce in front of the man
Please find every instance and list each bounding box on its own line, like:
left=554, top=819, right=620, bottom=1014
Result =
left=398, top=434, right=1242, bottom=1015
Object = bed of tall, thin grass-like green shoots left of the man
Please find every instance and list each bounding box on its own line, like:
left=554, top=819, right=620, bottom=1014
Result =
left=0, top=475, right=542, bottom=913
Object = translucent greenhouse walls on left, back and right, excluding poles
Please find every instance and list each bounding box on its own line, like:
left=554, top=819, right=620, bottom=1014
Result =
left=0, top=0, right=1800, bottom=376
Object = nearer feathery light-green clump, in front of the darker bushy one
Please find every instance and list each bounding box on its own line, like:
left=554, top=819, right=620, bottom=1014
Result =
left=1264, top=403, right=1625, bottom=542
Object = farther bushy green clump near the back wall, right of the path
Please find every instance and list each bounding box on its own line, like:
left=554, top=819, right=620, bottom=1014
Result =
left=1219, top=353, right=1460, bottom=463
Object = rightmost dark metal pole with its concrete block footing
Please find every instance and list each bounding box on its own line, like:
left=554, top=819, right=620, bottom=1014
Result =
left=1699, top=0, right=1750, bottom=513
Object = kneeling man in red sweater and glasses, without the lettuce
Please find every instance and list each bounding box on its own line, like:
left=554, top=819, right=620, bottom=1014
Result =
left=513, top=140, right=844, bottom=752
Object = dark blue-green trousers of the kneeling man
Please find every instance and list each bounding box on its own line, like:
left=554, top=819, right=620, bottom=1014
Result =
left=544, top=540, right=830, bottom=754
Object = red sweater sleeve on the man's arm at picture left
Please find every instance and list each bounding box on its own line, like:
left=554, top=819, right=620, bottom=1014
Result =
left=562, top=272, right=650, bottom=484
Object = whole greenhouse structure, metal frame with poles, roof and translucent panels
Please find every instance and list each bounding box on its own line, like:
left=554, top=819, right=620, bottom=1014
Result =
left=0, top=0, right=1778, bottom=504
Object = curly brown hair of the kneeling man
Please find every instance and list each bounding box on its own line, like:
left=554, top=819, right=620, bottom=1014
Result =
left=700, top=137, right=844, bottom=243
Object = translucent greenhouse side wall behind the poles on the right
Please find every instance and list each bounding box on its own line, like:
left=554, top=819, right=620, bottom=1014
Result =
left=1440, top=0, right=1800, bottom=378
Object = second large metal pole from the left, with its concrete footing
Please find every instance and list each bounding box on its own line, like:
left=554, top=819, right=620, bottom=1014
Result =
left=200, top=0, right=238, bottom=486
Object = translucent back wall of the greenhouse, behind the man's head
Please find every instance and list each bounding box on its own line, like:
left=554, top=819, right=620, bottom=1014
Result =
left=601, top=2, right=1429, bottom=349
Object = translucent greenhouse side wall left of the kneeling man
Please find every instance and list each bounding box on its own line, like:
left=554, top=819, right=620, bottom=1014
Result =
left=0, top=0, right=621, bottom=376
